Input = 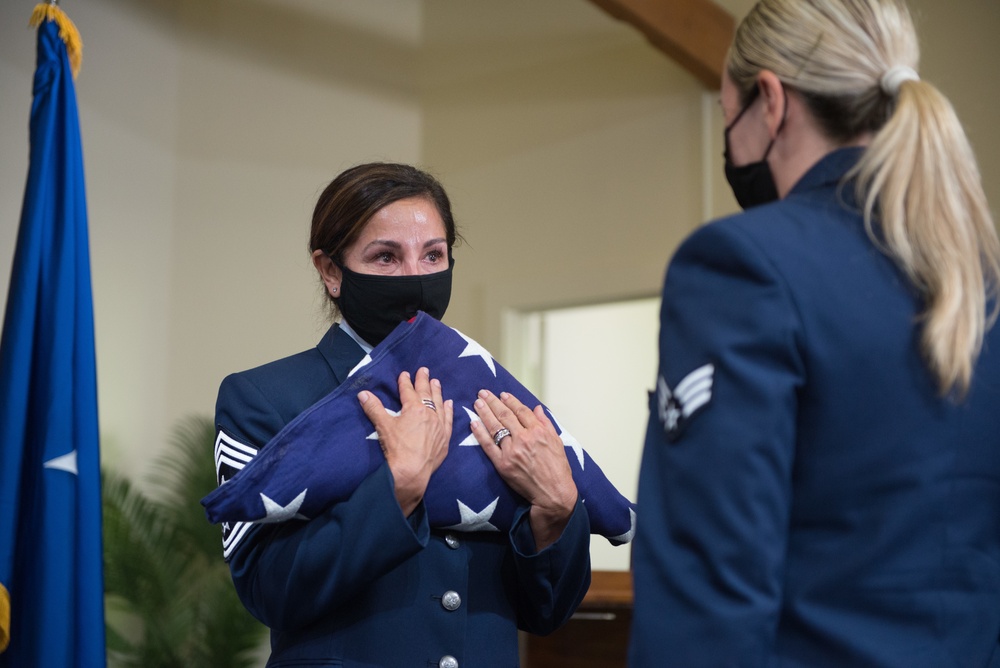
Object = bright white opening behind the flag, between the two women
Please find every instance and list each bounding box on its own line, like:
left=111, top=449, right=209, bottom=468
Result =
left=504, top=296, right=660, bottom=571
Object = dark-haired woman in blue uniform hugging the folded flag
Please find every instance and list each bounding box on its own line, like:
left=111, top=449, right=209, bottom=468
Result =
left=216, top=163, right=590, bottom=668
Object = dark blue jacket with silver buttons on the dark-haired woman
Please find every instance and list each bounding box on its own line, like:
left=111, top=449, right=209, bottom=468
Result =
left=216, top=325, right=590, bottom=668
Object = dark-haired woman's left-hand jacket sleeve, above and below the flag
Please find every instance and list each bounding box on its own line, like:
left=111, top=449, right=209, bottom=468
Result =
left=216, top=374, right=430, bottom=630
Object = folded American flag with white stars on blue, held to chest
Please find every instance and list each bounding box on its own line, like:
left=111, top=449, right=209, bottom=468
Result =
left=201, top=312, right=635, bottom=545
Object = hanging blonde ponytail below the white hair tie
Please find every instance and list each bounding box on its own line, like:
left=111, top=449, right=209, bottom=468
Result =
left=850, top=81, right=1000, bottom=397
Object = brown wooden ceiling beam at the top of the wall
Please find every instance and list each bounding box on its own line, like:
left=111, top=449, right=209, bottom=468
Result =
left=590, top=0, right=736, bottom=89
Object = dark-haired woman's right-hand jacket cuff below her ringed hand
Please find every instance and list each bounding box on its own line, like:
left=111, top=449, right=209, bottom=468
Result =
left=510, top=500, right=590, bottom=635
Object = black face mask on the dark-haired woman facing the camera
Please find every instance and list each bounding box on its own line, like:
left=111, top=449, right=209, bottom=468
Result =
left=337, top=258, right=455, bottom=346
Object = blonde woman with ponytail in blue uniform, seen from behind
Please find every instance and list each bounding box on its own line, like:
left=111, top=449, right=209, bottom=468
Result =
left=630, top=0, right=1000, bottom=668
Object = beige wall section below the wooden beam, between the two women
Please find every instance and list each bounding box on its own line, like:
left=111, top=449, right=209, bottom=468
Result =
left=423, top=0, right=705, bottom=350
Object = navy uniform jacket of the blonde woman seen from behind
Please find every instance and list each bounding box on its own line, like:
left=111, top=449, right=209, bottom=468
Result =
left=630, top=149, right=1000, bottom=668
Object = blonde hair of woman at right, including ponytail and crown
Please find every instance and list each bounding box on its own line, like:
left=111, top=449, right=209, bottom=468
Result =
left=727, top=0, right=1000, bottom=398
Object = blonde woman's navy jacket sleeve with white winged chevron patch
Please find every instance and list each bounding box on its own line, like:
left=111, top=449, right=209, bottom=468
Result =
left=631, top=224, right=805, bottom=667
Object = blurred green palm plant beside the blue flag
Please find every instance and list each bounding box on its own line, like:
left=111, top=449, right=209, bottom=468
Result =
left=102, top=417, right=266, bottom=668
